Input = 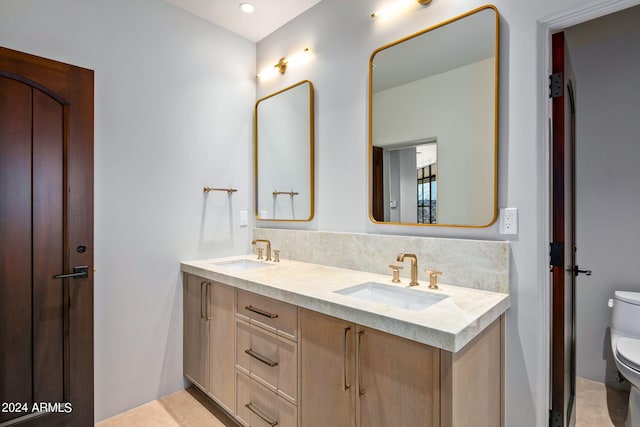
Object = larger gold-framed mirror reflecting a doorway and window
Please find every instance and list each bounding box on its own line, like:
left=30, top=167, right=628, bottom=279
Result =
left=369, top=6, right=498, bottom=227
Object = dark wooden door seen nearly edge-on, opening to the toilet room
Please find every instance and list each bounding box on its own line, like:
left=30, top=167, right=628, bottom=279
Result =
left=549, top=33, right=577, bottom=427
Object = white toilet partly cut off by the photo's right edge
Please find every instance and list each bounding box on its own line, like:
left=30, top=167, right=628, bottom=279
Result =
left=609, top=291, right=640, bottom=427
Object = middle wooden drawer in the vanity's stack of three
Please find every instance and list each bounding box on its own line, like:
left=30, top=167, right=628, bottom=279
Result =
left=236, top=319, right=298, bottom=404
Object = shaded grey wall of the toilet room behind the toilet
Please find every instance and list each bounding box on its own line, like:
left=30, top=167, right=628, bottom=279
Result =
left=566, top=6, right=640, bottom=384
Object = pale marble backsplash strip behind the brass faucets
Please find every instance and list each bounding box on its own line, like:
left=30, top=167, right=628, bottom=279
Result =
left=253, top=228, right=509, bottom=293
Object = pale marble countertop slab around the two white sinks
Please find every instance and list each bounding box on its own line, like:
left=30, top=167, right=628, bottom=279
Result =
left=181, top=255, right=510, bottom=352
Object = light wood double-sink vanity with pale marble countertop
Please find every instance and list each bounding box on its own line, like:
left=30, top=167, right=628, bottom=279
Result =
left=181, top=255, right=509, bottom=427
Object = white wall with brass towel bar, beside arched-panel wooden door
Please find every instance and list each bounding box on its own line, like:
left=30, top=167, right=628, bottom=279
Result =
left=0, top=0, right=256, bottom=420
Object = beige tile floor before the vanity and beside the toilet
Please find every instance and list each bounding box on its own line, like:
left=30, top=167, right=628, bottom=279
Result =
left=96, top=378, right=629, bottom=427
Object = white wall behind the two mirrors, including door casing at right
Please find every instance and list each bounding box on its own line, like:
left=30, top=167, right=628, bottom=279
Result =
left=257, top=0, right=637, bottom=427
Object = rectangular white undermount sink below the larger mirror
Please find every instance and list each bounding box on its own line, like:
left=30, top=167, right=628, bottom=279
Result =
left=334, top=282, right=448, bottom=311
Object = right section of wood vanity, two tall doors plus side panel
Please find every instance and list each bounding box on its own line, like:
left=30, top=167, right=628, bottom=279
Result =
left=299, top=309, right=504, bottom=427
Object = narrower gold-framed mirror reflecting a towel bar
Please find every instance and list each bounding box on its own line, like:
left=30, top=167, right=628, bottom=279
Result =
left=255, top=80, right=314, bottom=221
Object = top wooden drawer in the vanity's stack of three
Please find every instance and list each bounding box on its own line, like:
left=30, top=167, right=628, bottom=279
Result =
left=236, top=290, right=298, bottom=340
